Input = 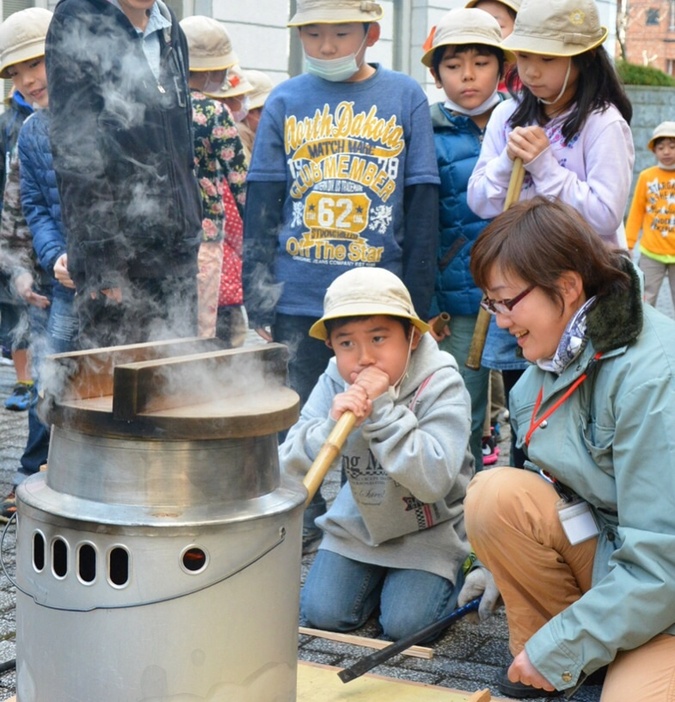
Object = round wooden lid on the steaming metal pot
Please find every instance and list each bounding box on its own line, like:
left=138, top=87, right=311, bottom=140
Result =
left=42, top=339, right=299, bottom=441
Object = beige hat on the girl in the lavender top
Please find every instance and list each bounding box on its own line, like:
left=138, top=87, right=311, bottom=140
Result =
left=502, top=0, right=607, bottom=56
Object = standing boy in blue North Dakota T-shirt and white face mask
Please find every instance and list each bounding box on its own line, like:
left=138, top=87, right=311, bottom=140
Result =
left=243, top=0, right=439, bottom=546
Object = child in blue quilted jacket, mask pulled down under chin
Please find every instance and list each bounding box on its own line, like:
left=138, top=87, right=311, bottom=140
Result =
left=422, top=8, right=513, bottom=470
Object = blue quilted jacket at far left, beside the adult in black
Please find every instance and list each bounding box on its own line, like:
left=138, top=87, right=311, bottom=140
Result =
left=18, top=110, right=73, bottom=297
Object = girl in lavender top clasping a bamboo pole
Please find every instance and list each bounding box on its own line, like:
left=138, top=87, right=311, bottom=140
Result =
left=467, top=0, right=634, bottom=476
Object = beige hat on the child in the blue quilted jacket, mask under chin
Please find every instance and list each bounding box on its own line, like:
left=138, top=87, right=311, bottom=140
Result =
left=422, top=7, right=516, bottom=68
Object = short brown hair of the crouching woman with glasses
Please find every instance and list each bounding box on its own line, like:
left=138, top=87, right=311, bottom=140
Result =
left=471, top=195, right=630, bottom=306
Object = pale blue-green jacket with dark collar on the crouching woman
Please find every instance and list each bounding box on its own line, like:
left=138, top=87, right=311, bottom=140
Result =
left=511, top=267, right=675, bottom=690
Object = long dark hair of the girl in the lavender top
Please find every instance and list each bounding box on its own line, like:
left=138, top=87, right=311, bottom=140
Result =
left=506, top=47, right=633, bottom=144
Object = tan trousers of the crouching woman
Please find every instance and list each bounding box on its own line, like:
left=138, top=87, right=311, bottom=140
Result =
left=465, top=468, right=675, bottom=702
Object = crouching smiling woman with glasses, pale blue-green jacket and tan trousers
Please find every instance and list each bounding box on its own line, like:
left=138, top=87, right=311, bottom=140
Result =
left=465, top=196, right=675, bottom=702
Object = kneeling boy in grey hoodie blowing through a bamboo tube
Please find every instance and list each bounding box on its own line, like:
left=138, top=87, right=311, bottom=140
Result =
left=279, top=267, right=486, bottom=639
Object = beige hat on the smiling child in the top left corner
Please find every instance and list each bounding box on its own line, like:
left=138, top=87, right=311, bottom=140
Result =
left=0, top=7, right=52, bottom=78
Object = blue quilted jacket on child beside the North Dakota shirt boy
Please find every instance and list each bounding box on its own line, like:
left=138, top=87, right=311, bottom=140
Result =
left=431, top=103, right=496, bottom=316
